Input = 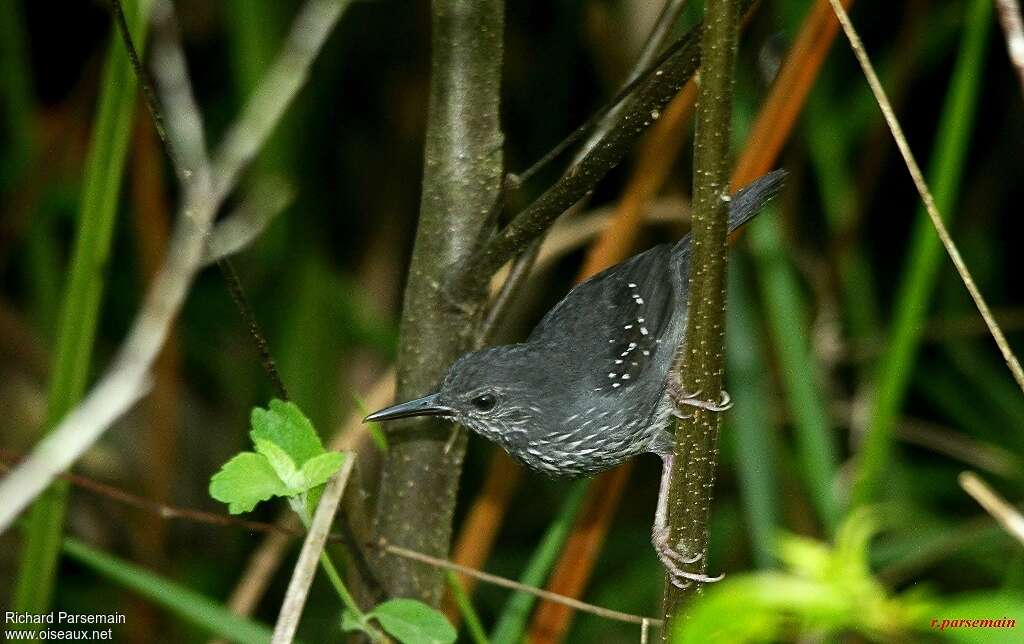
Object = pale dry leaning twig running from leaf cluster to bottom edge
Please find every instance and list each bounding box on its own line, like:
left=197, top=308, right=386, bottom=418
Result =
left=270, top=455, right=355, bottom=644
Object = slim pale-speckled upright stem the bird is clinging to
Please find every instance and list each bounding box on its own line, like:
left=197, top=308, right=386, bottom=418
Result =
left=664, top=0, right=740, bottom=641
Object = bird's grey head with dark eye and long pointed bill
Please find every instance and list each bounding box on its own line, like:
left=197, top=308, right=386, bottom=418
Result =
left=364, top=344, right=550, bottom=448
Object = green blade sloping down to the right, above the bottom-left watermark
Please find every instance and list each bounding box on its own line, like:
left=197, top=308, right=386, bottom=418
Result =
left=63, top=538, right=271, bottom=644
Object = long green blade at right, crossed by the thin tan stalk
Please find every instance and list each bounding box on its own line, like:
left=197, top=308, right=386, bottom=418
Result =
left=853, top=0, right=992, bottom=505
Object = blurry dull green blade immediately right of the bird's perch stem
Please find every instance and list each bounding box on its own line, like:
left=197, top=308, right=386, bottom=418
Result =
left=725, top=259, right=779, bottom=568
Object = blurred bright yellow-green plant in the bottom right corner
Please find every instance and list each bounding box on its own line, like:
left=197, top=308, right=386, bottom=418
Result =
left=672, top=509, right=1024, bottom=644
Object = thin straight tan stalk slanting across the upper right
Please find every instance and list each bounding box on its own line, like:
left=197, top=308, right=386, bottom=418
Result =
left=828, top=0, right=1024, bottom=391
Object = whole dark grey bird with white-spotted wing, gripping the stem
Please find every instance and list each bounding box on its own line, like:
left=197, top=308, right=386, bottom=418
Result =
left=365, top=170, right=785, bottom=587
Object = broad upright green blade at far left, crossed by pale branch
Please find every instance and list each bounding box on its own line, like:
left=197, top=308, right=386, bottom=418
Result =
left=14, top=0, right=150, bottom=613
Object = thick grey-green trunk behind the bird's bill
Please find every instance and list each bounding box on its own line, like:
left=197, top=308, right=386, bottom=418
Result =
left=375, top=0, right=504, bottom=604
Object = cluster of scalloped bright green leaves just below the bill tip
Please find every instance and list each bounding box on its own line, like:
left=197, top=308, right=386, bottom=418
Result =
left=210, top=399, right=345, bottom=514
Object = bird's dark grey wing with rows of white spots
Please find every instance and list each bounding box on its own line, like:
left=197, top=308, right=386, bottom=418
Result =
left=529, top=244, right=687, bottom=393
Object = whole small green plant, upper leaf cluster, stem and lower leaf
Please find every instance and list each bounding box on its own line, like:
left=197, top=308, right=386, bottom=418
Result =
left=210, top=399, right=456, bottom=644
